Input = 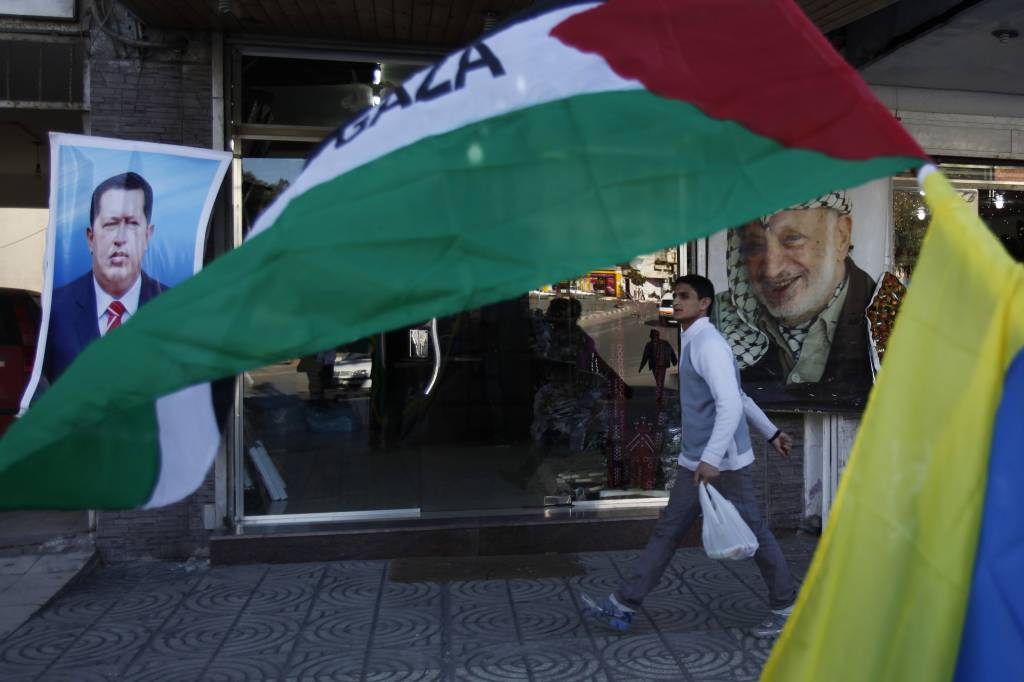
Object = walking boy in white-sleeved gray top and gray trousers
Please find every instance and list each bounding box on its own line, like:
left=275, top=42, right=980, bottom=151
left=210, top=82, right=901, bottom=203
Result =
left=581, top=274, right=797, bottom=637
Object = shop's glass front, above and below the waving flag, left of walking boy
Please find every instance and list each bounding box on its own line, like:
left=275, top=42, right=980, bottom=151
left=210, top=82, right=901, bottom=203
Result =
left=230, top=47, right=679, bottom=523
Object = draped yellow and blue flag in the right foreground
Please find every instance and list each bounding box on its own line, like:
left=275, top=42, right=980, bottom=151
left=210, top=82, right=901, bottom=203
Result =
left=761, top=167, right=1024, bottom=682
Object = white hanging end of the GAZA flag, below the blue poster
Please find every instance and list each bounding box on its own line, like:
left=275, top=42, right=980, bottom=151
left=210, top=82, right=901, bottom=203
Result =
left=143, top=384, right=220, bottom=509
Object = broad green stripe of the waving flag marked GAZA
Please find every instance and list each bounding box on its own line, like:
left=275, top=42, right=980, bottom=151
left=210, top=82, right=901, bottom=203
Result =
left=0, top=91, right=921, bottom=507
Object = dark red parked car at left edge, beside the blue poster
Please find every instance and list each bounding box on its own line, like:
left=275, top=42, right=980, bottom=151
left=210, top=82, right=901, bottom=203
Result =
left=0, top=289, right=40, bottom=434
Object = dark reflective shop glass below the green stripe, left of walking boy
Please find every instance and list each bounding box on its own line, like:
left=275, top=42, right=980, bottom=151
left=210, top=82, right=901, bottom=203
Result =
left=238, top=253, right=679, bottom=516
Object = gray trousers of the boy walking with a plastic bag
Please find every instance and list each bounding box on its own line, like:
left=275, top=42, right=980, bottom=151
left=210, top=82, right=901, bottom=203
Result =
left=615, top=466, right=797, bottom=609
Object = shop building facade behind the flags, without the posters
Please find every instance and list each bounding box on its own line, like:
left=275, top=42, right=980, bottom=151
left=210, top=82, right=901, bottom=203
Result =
left=0, top=0, right=1024, bottom=560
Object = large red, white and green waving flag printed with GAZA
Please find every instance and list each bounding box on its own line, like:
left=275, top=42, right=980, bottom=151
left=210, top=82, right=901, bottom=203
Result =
left=0, top=0, right=926, bottom=508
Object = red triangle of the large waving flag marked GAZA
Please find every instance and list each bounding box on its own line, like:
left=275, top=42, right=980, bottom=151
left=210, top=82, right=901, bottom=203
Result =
left=551, top=0, right=928, bottom=161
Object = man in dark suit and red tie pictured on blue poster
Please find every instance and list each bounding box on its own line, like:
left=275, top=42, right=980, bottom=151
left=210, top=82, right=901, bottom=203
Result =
left=43, top=172, right=167, bottom=383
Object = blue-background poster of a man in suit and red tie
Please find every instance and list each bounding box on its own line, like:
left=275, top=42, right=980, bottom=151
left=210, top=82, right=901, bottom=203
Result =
left=23, top=134, right=230, bottom=408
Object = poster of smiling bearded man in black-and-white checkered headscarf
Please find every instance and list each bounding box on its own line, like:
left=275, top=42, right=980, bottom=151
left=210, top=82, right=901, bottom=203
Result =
left=716, top=182, right=887, bottom=409
